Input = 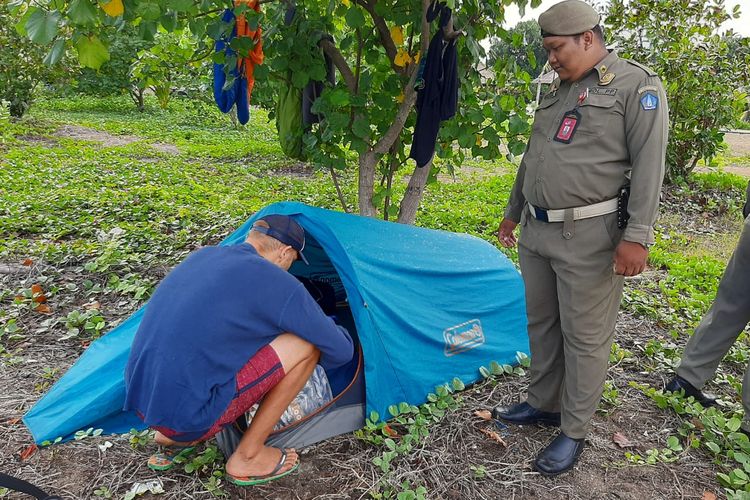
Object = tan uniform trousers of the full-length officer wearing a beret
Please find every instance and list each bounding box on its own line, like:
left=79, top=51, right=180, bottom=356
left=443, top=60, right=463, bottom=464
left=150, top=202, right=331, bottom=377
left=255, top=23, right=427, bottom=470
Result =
left=518, top=207, right=623, bottom=439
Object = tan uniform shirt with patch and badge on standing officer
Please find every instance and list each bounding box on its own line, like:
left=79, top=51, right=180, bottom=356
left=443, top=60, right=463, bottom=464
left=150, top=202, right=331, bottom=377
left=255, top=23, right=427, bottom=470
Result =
left=505, top=51, right=669, bottom=244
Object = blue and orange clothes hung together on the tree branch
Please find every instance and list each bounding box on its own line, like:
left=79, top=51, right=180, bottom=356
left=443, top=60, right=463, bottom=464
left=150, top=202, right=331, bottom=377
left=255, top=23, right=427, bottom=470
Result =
left=214, top=0, right=264, bottom=125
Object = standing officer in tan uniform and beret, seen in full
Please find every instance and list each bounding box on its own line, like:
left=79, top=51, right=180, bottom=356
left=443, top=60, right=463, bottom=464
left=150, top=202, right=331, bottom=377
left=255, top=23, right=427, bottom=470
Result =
left=494, top=0, right=668, bottom=475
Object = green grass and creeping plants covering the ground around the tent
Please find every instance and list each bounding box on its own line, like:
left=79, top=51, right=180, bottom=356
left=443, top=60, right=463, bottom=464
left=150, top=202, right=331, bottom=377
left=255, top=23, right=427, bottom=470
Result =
left=0, top=93, right=750, bottom=496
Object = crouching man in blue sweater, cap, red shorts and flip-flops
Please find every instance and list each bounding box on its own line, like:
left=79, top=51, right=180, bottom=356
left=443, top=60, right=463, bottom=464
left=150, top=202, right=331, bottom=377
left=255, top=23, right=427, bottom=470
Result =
left=125, top=215, right=354, bottom=486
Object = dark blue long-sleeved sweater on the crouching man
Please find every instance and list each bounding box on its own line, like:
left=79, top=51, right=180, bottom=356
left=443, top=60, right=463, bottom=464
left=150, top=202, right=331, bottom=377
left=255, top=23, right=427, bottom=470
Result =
left=124, top=243, right=354, bottom=432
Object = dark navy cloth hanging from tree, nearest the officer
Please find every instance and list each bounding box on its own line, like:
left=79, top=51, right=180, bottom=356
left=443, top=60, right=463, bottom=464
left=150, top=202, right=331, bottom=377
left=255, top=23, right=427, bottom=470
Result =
left=409, top=2, right=458, bottom=167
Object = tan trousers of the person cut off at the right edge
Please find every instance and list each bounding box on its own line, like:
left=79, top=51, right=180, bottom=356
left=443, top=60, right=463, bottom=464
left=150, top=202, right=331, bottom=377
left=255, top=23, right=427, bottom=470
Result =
left=677, top=217, right=750, bottom=430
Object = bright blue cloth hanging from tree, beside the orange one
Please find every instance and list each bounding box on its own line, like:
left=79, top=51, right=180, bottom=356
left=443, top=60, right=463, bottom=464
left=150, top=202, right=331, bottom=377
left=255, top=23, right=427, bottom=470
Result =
left=214, top=9, right=250, bottom=125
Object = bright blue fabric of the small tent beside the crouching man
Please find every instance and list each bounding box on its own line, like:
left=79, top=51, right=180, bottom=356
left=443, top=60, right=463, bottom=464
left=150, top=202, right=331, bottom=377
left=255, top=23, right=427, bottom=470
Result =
left=24, top=202, right=528, bottom=443
